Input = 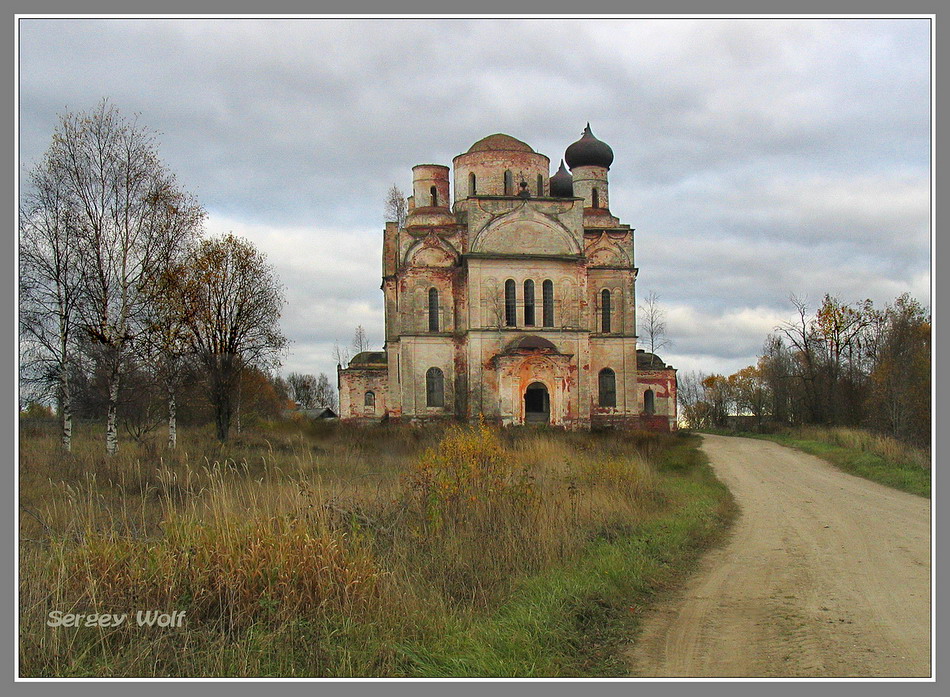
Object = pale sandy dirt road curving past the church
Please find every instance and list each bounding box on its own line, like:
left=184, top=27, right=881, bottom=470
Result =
left=629, top=436, right=930, bottom=677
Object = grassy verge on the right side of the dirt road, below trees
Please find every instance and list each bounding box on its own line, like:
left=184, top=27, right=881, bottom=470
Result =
left=704, top=427, right=931, bottom=498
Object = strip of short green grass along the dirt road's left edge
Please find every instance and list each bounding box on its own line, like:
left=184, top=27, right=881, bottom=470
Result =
left=401, top=435, right=736, bottom=677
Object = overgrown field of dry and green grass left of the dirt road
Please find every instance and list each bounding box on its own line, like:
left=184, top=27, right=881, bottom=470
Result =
left=19, top=420, right=732, bottom=677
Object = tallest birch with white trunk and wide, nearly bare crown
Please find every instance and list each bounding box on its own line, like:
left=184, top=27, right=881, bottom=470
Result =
left=32, top=100, right=203, bottom=455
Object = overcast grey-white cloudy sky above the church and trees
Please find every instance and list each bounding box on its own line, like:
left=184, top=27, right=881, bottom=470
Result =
left=19, top=19, right=931, bottom=382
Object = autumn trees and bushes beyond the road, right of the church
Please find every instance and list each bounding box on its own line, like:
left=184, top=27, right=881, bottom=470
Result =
left=679, top=294, right=931, bottom=446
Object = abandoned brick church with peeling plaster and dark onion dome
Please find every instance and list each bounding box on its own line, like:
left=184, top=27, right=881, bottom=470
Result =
left=338, top=125, right=676, bottom=430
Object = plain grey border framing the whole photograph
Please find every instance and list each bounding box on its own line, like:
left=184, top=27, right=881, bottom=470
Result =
left=0, top=0, right=950, bottom=697
